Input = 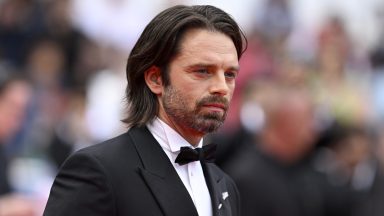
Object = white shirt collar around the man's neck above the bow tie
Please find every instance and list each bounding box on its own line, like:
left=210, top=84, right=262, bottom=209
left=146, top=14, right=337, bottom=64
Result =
left=147, top=117, right=203, bottom=153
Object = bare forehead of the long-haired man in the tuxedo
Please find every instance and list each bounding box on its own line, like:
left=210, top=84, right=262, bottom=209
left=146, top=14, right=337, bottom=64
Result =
left=176, top=29, right=238, bottom=65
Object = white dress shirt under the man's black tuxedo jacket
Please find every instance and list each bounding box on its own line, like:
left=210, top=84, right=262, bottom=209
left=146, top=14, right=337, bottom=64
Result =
left=147, top=118, right=212, bottom=216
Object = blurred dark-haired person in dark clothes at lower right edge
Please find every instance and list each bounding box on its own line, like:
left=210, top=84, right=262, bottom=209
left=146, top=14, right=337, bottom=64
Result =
left=314, top=123, right=384, bottom=216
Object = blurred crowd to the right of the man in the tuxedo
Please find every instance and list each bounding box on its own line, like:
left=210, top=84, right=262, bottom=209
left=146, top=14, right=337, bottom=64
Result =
left=211, top=0, right=384, bottom=216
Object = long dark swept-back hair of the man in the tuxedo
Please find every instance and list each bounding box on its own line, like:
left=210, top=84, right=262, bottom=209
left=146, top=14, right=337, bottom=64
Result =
left=123, top=5, right=247, bottom=126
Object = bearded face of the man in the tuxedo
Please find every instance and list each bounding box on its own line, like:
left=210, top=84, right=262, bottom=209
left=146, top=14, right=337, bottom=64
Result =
left=160, top=29, right=239, bottom=136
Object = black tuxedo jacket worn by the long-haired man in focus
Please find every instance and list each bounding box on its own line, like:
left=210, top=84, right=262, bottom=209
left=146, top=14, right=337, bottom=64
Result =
left=44, top=127, right=240, bottom=216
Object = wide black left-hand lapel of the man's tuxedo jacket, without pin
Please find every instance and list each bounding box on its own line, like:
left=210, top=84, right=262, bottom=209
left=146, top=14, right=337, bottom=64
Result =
left=129, top=128, right=198, bottom=216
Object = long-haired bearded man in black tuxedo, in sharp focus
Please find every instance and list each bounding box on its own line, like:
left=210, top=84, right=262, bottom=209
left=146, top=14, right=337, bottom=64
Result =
left=44, top=6, right=245, bottom=216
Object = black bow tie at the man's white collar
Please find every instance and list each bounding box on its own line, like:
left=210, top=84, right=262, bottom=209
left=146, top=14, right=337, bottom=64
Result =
left=175, top=144, right=216, bottom=165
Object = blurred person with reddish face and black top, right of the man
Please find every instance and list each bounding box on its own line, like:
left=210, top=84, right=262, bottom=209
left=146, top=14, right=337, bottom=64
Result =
left=218, top=82, right=325, bottom=216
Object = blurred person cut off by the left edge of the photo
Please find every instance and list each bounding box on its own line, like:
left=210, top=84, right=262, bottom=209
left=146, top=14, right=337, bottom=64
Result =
left=0, top=63, right=38, bottom=216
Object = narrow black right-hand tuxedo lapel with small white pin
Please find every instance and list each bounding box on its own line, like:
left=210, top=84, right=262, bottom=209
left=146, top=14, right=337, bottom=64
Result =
left=202, top=163, right=232, bottom=216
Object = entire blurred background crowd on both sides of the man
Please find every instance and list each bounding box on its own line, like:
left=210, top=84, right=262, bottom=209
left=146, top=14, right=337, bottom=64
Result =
left=0, top=0, right=384, bottom=216
